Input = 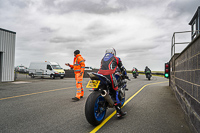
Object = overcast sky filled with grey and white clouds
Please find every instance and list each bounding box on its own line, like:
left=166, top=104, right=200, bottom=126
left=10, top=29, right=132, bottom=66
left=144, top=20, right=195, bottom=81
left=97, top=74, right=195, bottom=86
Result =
left=0, top=0, right=200, bottom=71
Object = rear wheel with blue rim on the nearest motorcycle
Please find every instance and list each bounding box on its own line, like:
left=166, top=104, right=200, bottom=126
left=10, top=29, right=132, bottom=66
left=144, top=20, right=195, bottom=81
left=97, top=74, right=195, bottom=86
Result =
left=85, top=91, right=106, bottom=126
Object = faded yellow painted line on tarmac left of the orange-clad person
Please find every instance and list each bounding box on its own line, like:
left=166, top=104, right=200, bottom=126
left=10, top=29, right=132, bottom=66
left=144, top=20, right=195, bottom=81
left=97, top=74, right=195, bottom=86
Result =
left=0, top=87, right=73, bottom=100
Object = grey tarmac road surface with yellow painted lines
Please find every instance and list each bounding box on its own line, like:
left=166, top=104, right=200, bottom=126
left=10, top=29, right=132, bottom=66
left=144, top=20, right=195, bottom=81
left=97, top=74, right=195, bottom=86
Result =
left=0, top=75, right=191, bottom=133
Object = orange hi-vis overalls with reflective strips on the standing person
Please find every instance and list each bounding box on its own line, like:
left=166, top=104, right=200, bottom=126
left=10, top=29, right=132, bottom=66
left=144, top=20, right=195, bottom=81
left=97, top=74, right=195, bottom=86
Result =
left=70, top=54, right=85, bottom=99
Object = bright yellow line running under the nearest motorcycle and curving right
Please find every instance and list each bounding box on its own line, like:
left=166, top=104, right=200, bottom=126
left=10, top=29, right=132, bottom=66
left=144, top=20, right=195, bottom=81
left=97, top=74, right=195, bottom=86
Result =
left=90, top=81, right=169, bottom=133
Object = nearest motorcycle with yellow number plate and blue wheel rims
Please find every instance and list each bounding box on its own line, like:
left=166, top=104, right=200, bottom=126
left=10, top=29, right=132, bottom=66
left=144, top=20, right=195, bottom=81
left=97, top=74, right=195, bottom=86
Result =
left=85, top=72, right=130, bottom=126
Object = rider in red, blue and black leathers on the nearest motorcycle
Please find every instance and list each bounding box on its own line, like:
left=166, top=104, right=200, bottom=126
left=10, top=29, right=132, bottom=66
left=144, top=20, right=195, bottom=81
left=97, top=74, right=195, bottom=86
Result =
left=98, top=48, right=126, bottom=118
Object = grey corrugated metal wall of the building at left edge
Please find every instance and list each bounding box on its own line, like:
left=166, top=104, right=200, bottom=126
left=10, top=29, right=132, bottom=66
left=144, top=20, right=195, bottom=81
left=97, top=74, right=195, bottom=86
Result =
left=0, top=28, right=16, bottom=82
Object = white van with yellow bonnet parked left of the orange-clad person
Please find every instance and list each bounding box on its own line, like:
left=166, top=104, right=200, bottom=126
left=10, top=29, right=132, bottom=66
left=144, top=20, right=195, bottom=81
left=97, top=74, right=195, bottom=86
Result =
left=29, top=61, right=65, bottom=79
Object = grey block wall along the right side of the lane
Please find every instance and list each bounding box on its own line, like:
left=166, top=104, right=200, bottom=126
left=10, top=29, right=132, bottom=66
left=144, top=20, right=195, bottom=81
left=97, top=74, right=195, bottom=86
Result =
left=169, top=36, right=200, bottom=133
